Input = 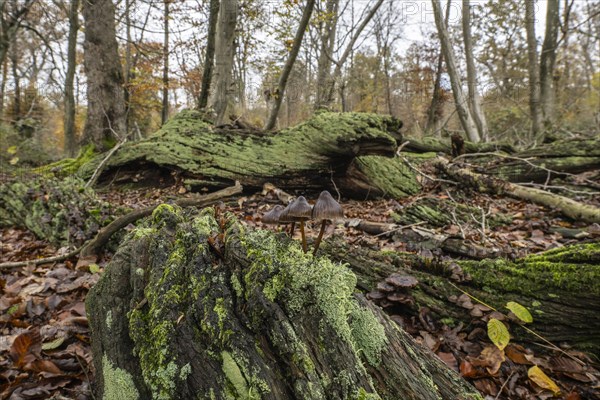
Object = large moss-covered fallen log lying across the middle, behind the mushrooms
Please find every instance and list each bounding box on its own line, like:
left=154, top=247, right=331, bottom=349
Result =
left=80, top=111, right=418, bottom=195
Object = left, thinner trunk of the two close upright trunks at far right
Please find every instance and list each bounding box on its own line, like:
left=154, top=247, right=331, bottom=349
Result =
left=525, top=0, right=542, bottom=136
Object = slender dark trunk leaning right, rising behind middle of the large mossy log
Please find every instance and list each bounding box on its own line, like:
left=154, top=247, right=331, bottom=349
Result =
left=264, top=0, right=315, bottom=131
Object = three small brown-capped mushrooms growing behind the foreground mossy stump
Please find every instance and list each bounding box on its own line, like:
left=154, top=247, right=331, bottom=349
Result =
left=262, top=190, right=344, bottom=254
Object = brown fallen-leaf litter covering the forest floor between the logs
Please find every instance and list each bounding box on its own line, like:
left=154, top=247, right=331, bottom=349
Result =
left=0, top=182, right=600, bottom=400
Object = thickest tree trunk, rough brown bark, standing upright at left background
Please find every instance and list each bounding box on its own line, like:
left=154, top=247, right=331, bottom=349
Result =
left=82, top=0, right=126, bottom=151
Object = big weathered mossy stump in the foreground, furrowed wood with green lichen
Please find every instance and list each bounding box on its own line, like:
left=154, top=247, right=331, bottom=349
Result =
left=87, top=205, right=480, bottom=400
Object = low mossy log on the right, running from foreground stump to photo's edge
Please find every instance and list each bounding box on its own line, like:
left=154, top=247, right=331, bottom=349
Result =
left=322, top=240, right=600, bottom=355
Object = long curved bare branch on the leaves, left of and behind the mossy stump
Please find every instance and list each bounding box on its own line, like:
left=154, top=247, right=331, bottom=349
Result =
left=0, top=182, right=243, bottom=269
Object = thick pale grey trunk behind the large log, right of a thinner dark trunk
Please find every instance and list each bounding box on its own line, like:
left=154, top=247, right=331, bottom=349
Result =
left=208, top=0, right=239, bottom=125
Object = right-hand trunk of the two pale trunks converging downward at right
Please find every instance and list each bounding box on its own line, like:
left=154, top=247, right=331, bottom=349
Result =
left=462, top=0, right=488, bottom=141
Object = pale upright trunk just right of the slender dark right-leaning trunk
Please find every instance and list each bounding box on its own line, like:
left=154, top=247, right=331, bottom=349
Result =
left=315, top=0, right=340, bottom=110
